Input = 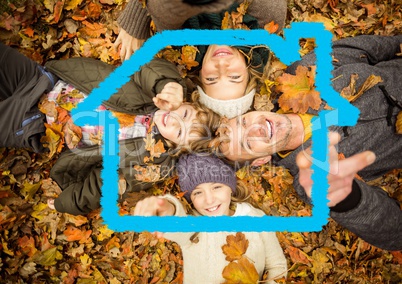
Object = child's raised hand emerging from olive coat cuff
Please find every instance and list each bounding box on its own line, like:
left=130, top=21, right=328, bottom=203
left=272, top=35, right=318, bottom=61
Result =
left=153, top=82, right=184, bottom=111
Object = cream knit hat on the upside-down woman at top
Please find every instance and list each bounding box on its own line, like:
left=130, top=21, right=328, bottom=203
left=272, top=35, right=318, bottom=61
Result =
left=197, top=86, right=255, bottom=119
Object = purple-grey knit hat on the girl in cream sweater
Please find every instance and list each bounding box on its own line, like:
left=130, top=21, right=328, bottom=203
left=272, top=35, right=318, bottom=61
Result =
left=176, top=154, right=237, bottom=202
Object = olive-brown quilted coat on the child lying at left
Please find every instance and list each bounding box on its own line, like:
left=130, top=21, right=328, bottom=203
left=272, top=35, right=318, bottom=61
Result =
left=45, top=58, right=187, bottom=215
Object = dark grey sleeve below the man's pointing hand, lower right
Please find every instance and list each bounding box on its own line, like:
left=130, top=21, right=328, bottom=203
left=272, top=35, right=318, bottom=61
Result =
left=331, top=180, right=402, bottom=250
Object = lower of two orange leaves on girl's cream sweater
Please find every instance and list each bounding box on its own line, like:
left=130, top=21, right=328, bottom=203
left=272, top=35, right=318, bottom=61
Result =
left=222, top=257, right=259, bottom=283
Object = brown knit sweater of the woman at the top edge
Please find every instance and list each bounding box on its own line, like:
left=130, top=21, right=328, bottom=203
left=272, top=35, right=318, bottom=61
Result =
left=117, top=0, right=287, bottom=39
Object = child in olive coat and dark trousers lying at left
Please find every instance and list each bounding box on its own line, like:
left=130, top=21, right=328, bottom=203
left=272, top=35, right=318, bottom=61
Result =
left=0, top=43, right=220, bottom=214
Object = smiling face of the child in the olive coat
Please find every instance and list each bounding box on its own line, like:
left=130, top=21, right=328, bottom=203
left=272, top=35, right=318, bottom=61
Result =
left=154, top=103, right=197, bottom=145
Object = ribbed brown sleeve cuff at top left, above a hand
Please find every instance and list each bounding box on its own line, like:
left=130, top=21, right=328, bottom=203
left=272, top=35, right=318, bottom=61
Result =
left=117, top=0, right=152, bottom=39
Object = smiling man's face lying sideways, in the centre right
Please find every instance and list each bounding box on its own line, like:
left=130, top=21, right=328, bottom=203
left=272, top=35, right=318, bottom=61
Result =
left=219, top=111, right=292, bottom=161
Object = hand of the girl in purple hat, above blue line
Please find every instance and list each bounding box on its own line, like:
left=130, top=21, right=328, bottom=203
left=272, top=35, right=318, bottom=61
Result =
left=134, top=196, right=176, bottom=216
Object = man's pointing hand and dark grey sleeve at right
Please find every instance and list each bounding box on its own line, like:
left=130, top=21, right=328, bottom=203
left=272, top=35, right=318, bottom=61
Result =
left=297, top=132, right=402, bottom=250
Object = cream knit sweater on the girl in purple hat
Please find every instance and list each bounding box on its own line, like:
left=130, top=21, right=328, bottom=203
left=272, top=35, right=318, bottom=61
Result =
left=161, top=195, right=287, bottom=283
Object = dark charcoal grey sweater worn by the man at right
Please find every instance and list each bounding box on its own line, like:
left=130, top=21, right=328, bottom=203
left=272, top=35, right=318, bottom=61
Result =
left=274, top=35, right=402, bottom=250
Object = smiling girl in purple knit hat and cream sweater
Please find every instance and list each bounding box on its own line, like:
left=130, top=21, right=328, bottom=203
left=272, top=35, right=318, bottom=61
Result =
left=134, top=154, right=287, bottom=283
